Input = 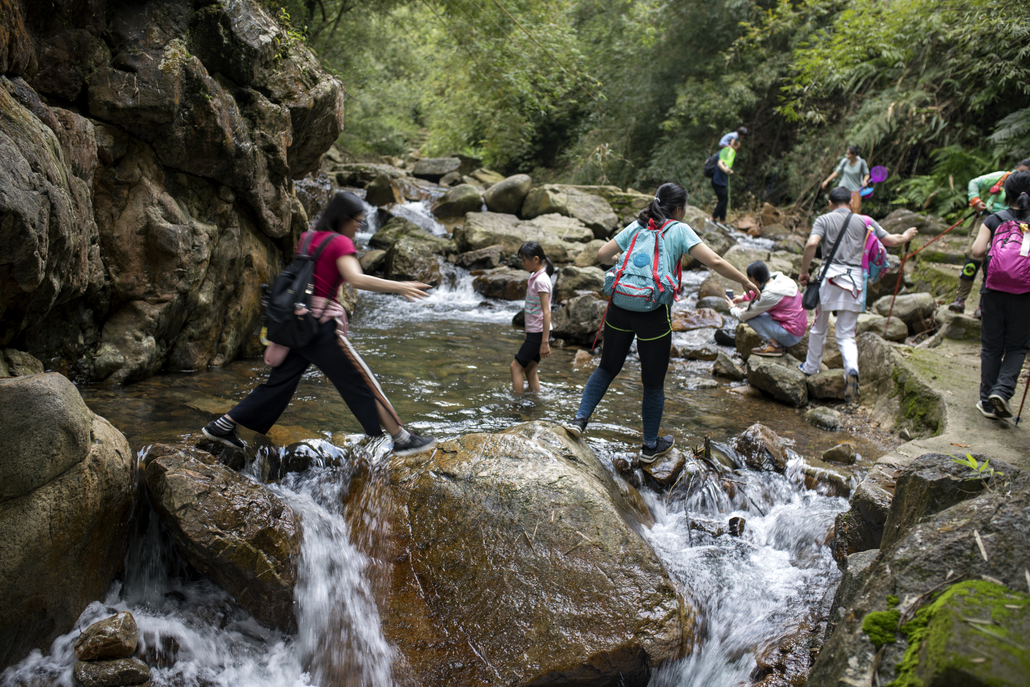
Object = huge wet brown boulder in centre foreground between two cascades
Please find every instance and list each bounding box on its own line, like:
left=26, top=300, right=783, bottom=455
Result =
left=366, top=422, right=695, bottom=686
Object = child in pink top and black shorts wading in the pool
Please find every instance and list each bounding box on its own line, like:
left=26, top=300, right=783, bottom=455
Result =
left=512, top=241, right=554, bottom=394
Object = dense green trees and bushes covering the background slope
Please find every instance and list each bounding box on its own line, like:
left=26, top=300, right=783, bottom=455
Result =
left=266, top=0, right=1030, bottom=213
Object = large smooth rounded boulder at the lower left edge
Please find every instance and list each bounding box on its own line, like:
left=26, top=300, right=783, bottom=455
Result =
left=0, top=373, right=135, bottom=666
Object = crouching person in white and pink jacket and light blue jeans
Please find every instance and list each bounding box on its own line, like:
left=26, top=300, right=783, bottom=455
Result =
left=727, top=260, right=809, bottom=357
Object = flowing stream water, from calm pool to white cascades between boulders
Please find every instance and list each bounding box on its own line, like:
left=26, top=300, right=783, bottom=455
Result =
left=0, top=197, right=885, bottom=687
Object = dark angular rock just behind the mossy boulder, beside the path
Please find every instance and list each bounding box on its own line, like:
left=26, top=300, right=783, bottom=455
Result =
left=880, top=453, right=988, bottom=548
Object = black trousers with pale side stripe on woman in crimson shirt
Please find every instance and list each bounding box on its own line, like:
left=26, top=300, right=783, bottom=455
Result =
left=228, top=319, right=401, bottom=437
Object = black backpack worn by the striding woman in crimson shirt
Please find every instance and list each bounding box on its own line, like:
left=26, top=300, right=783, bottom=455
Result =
left=265, top=234, right=336, bottom=348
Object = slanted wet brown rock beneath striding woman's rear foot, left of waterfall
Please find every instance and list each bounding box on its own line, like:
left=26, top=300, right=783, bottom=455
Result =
left=145, top=446, right=301, bottom=631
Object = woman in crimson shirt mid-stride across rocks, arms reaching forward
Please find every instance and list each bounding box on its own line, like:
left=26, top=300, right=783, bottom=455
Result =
left=203, top=192, right=437, bottom=455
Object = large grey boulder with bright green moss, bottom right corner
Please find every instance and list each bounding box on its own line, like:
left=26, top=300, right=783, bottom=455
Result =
left=808, top=454, right=1030, bottom=686
